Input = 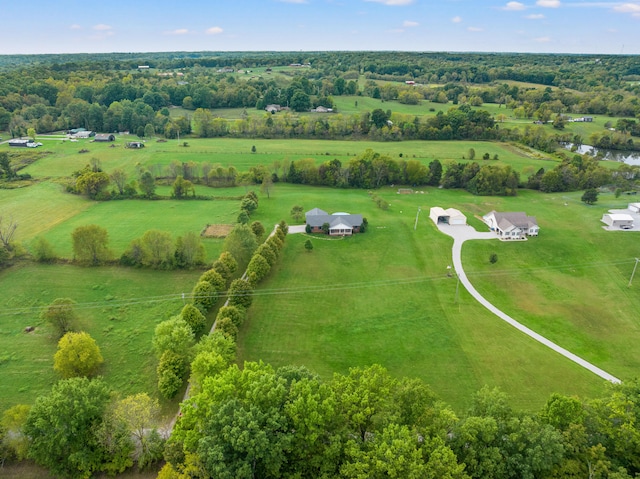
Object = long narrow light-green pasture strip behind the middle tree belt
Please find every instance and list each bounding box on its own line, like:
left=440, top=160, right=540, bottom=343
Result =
left=11, top=137, right=553, bottom=183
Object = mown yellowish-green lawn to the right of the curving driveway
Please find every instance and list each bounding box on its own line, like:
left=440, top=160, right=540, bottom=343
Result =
left=463, top=192, right=640, bottom=380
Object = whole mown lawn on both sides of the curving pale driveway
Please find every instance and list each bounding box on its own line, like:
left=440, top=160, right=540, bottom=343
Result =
left=239, top=188, right=640, bottom=409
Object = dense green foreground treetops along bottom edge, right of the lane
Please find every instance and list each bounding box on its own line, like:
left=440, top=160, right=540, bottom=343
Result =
left=159, top=363, right=640, bottom=479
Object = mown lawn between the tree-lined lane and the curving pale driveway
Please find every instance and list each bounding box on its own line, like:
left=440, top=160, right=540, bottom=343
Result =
left=239, top=188, right=604, bottom=409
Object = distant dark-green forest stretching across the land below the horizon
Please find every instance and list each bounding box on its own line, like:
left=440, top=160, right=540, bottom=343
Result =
left=0, top=52, right=640, bottom=146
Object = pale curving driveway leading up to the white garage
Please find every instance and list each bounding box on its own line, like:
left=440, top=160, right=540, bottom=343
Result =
left=438, top=225, right=621, bottom=383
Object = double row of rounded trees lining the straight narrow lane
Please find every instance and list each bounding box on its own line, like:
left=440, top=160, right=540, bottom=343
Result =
left=153, top=218, right=286, bottom=398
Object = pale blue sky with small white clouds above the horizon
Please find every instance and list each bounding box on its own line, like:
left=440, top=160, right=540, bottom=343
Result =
left=0, top=0, right=640, bottom=54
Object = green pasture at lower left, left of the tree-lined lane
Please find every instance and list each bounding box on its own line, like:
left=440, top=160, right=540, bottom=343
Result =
left=0, top=264, right=199, bottom=411
